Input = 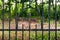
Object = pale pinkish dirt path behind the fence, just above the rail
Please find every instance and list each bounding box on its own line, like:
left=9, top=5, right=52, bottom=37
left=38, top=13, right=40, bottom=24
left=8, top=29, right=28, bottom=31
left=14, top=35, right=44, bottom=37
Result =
left=0, top=21, right=60, bottom=29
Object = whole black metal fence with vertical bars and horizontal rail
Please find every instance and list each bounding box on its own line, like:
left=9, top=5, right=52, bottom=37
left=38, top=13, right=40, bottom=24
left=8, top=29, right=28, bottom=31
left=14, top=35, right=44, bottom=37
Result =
left=0, top=0, right=60, bottom=40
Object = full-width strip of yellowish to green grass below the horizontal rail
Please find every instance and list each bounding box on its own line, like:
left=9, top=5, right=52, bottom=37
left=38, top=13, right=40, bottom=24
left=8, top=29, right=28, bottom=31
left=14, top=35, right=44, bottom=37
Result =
left=0, top=31, right=60, bottom=40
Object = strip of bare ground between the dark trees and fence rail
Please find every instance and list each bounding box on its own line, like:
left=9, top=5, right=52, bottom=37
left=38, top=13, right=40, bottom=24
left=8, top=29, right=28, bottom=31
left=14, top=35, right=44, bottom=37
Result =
left=0, top=20, right=60, bottom=29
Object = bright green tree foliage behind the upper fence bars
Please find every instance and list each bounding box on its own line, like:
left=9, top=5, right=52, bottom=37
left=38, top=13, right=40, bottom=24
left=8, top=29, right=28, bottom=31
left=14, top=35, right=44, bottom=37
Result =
left=0, top=0, right=60, bottom=19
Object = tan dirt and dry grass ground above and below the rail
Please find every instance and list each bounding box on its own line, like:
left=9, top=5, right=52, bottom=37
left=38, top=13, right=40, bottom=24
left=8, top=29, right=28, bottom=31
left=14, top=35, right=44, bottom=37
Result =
left=0, top=20, right=60, bottom=40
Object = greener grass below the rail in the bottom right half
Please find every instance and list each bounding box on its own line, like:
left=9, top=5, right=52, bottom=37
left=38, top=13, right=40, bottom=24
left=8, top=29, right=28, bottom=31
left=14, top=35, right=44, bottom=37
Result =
left=31, top=32, right=60, bottom=40
